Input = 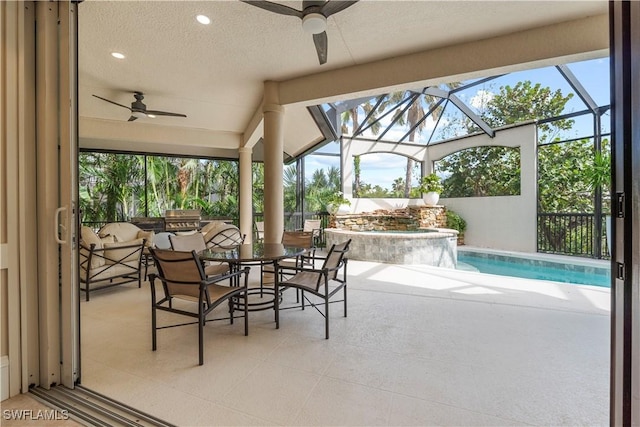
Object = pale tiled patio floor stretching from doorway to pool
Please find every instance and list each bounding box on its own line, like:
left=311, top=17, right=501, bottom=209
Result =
left=45, top=261, right=610, bottom=426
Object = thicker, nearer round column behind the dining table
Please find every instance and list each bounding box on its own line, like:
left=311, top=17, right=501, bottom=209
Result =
left=262, top=82, right=284, bottom=243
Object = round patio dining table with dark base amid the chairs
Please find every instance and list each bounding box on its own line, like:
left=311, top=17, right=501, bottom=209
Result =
left=198, top=242, right=308, bottom=311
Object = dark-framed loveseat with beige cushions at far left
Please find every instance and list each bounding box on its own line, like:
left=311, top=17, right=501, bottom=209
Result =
left=80, top=222, right=154, bottom=301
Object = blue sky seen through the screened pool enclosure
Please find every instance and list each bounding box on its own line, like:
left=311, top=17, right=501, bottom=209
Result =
left=305, top=57, right=610, bottom=188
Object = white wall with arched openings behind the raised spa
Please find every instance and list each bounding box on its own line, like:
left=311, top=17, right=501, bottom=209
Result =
left=342, top=123, right=537, bottom=252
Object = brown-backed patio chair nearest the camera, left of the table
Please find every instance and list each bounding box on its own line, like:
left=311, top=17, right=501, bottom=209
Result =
left=149, top=248, right=249, bottom=365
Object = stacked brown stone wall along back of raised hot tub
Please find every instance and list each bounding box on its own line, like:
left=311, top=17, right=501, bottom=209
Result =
left=329, top=206, right=447, bottom=231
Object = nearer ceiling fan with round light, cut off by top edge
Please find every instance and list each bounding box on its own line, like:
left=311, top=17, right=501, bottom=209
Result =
left=240, top=0, right=358, bottom=65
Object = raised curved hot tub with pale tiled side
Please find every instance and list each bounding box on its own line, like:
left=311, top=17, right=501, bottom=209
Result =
left=324, top=228, right=458, bottom=268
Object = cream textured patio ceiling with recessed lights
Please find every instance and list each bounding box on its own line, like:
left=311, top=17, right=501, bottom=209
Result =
left=78, top=0, right=607, bottom=157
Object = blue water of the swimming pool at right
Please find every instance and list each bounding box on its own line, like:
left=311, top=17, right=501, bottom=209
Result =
left=458, top=251, right=611, bottom=288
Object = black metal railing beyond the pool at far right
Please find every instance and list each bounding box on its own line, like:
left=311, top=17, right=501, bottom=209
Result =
left=538, top=213, right=609, bottom=259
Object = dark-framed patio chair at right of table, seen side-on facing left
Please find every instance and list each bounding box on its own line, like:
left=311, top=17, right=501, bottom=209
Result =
left=275, top=239, right=351, bottom=339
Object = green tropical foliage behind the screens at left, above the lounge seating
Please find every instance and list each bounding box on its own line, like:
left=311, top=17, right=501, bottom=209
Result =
left=78, top=152, right=238, bottom=222
